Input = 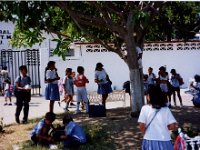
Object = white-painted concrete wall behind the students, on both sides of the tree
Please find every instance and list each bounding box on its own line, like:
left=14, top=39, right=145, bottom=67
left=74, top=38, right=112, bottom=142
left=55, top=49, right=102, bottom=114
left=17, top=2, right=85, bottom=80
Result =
left=0, top=22, right=200, bottom=93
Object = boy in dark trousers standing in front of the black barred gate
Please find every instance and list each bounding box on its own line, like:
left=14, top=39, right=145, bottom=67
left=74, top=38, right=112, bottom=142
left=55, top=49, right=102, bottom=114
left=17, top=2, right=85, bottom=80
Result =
left=15, top=65, right=31, bottom=124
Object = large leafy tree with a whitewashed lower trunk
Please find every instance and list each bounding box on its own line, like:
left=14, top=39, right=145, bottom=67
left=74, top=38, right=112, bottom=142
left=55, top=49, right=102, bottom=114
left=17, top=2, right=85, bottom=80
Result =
left=0, top=1, right=199, bottom=113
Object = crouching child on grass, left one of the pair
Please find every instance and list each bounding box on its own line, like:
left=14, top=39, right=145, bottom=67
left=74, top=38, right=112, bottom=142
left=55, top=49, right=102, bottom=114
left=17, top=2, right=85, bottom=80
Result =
left=31, top=112, right=56, bottom=146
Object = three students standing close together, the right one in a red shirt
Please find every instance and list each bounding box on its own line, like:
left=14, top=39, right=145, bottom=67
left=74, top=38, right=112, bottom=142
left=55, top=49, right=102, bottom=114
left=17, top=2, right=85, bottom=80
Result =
left=45, top=61, right=89, bottom=113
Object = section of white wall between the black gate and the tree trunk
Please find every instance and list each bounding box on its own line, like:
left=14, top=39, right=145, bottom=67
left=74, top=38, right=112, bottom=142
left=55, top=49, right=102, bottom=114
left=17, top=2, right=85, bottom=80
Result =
left=40, top=44, right=129, bottom=93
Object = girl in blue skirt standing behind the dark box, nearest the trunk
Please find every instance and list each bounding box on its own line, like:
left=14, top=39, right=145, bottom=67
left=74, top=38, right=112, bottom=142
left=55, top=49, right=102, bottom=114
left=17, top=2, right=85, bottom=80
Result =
left=95, top=63, right=112, bottom=106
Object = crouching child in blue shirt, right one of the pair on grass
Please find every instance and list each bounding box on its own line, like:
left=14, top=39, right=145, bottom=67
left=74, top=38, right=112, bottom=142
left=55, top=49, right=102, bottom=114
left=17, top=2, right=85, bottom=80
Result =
left=60, top=114, right=86, bottom=148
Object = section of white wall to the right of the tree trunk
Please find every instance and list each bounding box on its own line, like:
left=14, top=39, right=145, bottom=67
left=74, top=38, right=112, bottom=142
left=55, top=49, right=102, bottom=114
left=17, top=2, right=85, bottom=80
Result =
left=143, top=42, right=200, bottom=88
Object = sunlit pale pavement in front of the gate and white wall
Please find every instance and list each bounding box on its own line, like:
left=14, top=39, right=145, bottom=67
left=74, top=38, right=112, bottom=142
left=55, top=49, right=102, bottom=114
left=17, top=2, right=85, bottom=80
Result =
left=0, top=90, right=193, bottom=125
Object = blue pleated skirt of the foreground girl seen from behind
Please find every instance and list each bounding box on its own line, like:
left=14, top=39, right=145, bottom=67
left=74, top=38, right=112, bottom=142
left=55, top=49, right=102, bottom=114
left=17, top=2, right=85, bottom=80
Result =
left=142, top=139, right=174, bottom=150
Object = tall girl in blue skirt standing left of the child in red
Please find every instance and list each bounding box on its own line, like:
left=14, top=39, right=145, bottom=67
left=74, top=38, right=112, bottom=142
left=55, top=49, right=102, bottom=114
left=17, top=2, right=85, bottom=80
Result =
left=45, top=61, right=60, bottom=112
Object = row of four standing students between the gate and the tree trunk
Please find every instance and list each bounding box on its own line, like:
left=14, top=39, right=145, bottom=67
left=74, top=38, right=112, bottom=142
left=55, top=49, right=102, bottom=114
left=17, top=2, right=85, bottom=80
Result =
left=45, top=61, right=112, bottom=113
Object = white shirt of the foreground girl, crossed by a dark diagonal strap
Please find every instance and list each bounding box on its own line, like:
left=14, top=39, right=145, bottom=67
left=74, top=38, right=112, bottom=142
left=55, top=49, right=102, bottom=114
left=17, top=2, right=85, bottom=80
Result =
left=138, top=105, right=176, bottom=141
